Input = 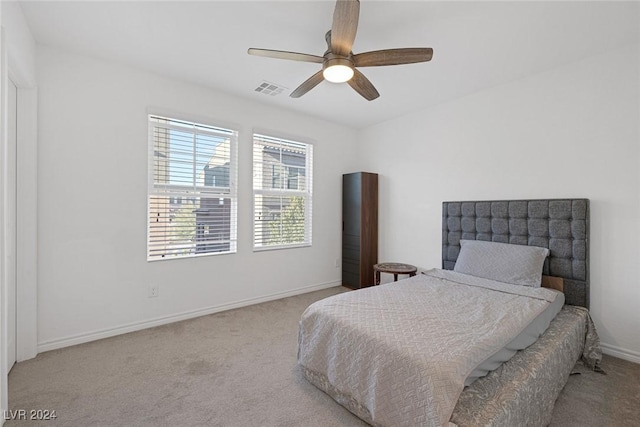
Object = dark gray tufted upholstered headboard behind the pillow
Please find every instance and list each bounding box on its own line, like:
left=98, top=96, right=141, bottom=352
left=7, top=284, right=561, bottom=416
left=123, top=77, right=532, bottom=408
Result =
left=442, top=199, right=589, bottom=307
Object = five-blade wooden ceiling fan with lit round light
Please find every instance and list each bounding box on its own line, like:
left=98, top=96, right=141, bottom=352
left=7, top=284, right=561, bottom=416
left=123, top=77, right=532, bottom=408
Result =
left=248, top=0, right=433, bottom=101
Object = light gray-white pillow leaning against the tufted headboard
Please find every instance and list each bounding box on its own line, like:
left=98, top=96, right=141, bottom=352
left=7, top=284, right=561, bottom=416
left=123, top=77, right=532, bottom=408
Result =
left=453, top=240, right=549, bottom=288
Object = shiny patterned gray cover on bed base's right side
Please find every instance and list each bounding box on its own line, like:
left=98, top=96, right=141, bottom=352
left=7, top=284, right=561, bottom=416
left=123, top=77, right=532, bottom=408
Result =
left=451, top=306, right=602, bottom=427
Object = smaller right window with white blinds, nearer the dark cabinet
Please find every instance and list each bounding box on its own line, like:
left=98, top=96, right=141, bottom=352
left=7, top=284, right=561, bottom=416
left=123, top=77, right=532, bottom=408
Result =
left=253, top=134, right=313, bottom=250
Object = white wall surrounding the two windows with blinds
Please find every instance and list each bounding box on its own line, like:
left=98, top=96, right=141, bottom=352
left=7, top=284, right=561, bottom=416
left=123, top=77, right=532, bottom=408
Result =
left=37, top=47, right=356, bottom=351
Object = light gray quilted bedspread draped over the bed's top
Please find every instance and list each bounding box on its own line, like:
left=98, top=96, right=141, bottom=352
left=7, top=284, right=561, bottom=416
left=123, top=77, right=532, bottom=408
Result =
left=298, top=270, right=555, bottom=426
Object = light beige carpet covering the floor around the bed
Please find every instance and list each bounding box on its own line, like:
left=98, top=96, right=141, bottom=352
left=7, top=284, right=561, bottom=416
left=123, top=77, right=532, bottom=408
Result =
left=5, top=287, right=640, bottom=427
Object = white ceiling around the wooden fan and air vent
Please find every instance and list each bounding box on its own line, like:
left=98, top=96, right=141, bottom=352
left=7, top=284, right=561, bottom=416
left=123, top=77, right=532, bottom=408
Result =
left=20, top=0, right=640, bottom=128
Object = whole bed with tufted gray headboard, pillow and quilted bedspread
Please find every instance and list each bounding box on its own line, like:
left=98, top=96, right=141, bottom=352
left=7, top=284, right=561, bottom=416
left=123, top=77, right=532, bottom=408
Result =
left=298, top=199, right=601, bottom=427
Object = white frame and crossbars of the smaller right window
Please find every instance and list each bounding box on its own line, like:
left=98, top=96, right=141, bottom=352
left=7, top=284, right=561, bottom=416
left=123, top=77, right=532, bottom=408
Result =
left=251, top=129, right=315, bottom=252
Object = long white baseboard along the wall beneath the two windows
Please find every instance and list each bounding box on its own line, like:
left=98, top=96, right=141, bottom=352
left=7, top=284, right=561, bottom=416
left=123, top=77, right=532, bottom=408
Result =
left=38, top=280, right=342, bottom=353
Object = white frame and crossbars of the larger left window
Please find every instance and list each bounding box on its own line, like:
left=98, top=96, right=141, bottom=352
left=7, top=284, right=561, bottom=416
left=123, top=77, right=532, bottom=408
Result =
left=146, top=109, right=239, bottom=262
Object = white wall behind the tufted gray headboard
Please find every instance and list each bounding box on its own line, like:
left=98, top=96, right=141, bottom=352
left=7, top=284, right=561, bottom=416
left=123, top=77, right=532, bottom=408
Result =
left=358, top=45, right=640, bottom=363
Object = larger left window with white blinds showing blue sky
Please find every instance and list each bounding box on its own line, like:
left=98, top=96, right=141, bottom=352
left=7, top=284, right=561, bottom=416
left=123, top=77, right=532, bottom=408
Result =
left=147, top=115, right=238, bottom=260
